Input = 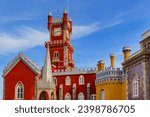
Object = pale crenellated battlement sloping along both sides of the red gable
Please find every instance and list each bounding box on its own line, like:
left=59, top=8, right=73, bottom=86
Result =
left=3, top=53, right=41, bottom=74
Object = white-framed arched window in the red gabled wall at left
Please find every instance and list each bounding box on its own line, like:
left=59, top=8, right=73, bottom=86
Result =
left=15, top=82, right=24, bottom=99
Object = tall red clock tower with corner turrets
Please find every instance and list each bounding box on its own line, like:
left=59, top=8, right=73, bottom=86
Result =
left=48, top=10, right=74, bottom=70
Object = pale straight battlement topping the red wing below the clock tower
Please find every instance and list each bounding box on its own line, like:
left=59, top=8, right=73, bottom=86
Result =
left=53, top=68, right=97, bottom=76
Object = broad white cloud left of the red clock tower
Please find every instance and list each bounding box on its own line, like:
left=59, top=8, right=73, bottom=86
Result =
left=0, top=27, right=48, bottom=54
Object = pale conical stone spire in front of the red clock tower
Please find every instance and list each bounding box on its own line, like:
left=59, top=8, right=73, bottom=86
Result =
left=42, top=42, right=53, bottom=82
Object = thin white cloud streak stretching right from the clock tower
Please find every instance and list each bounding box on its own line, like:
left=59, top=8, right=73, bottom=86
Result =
left=72, top=20, right=122, bottom=40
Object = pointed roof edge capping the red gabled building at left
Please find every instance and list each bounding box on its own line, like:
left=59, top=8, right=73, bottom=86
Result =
left=3, top=53, right=41, bottom=77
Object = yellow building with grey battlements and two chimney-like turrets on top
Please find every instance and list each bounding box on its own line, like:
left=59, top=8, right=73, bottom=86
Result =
left=95, top=54, right=126, bottom=100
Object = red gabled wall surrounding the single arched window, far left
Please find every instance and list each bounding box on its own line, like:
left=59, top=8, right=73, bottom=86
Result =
left=5, top=61, right=36, bottom=100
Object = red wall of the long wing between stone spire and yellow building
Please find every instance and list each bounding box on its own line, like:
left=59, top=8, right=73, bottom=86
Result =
left=54, top=73, right=96, bottom=100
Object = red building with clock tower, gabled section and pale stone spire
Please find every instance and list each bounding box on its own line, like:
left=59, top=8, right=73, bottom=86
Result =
left=3, top=10, right=96, bottom=100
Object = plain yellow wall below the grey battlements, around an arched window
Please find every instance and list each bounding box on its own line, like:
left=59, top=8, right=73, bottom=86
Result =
left=96, top=80, right=122, bottom=100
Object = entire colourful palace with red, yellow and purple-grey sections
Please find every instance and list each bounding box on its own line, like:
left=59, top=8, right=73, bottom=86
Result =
left=3, top=10, right=150, bottom=100
